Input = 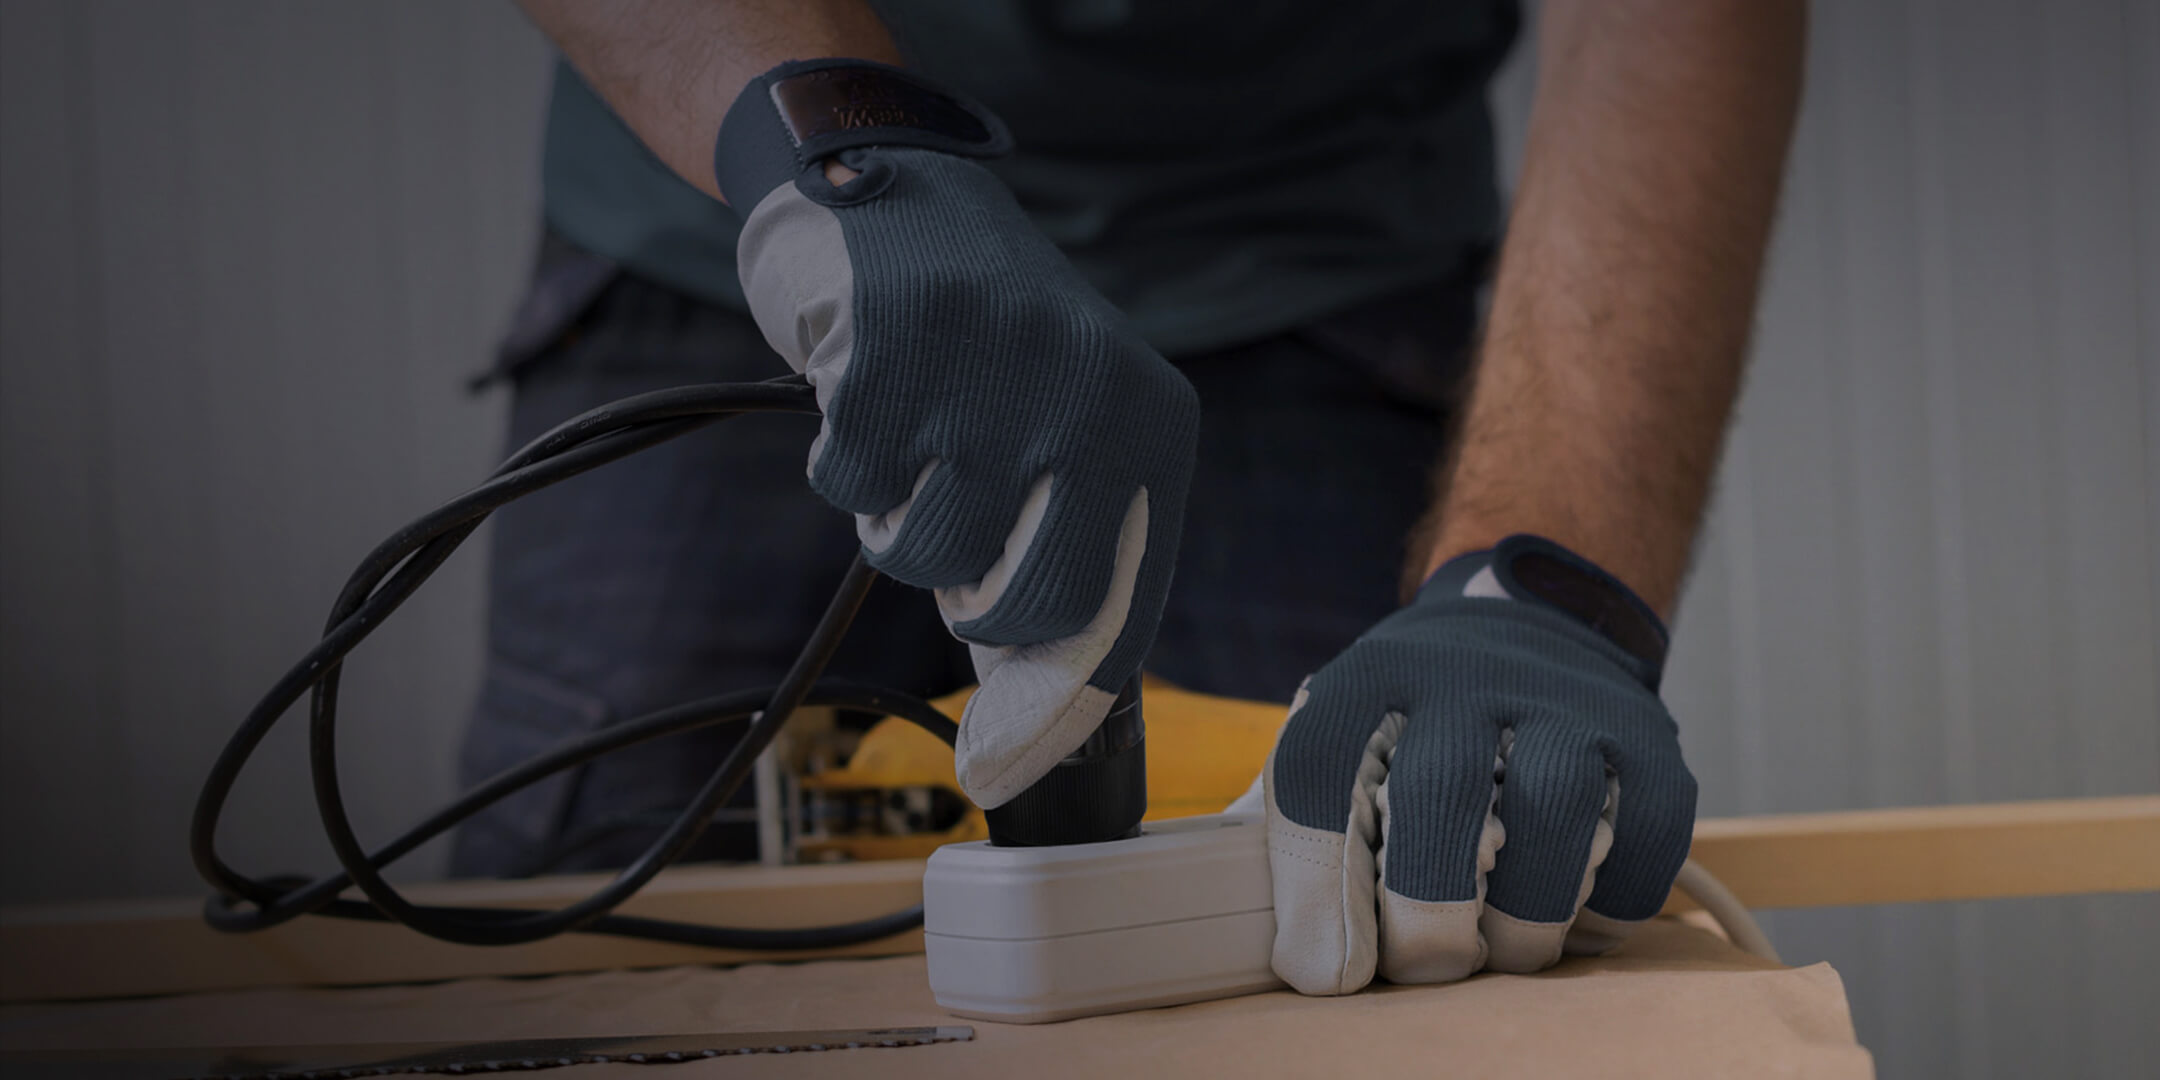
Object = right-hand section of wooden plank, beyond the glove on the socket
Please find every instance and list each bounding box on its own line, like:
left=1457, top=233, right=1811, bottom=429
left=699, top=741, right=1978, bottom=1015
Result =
left=1668, top=795, right=2160, bottom=912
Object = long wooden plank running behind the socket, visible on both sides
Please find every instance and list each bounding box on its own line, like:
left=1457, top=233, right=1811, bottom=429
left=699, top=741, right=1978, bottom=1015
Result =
left=0, top=795, right=2160, bottom=1002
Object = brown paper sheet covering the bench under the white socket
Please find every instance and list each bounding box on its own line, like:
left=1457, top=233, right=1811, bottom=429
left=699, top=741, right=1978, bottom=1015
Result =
left=0, top=918, right=1873, bottom=1080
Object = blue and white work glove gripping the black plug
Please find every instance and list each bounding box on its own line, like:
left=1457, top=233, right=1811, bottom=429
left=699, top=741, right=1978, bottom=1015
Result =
left=715, top=60, right=1199, bottom=808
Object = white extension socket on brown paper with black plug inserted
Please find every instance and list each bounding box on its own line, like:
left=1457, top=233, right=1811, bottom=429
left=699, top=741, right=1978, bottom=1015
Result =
left=922, top=814, right=1283, bottom=1024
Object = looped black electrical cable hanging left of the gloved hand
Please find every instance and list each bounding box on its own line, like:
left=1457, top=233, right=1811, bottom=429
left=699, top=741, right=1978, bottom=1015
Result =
left=190, top=376, right=957, bottom=950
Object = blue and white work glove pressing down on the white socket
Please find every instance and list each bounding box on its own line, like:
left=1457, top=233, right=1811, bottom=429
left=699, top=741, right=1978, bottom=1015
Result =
left=1261, top=536, right=1696, bottom=994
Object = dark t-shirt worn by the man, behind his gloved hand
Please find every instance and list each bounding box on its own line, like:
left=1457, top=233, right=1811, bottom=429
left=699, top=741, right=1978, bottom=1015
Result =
left=544, top=0, right=1516, bottom=354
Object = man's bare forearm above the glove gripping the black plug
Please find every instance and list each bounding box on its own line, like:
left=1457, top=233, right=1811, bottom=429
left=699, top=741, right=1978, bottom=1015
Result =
left=518, top=0, right=901, bottom=199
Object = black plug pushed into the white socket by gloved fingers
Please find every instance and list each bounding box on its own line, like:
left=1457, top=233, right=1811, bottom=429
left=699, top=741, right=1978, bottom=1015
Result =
left=983, top=676, right=1147, bottom=847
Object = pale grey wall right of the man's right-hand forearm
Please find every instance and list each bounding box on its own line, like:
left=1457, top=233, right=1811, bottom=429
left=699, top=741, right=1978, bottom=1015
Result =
left=1641, top=2, right=2160, bottom=1078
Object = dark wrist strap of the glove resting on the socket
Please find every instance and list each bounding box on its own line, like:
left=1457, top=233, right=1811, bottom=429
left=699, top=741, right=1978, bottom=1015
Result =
left=1417, top=534, right=1672, bottom=689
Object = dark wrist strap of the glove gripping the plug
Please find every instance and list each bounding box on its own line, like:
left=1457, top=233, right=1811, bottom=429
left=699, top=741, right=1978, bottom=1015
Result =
left=713, top=58, right=1013, bottom=216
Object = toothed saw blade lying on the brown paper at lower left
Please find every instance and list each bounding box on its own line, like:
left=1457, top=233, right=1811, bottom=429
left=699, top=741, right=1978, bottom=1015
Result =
left=0, top=1026, right=974, bottom=1080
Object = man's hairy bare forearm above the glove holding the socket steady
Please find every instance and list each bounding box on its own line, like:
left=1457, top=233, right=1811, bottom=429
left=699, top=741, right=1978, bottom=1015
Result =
left=1410, top=0, right=1806, bottom=618
